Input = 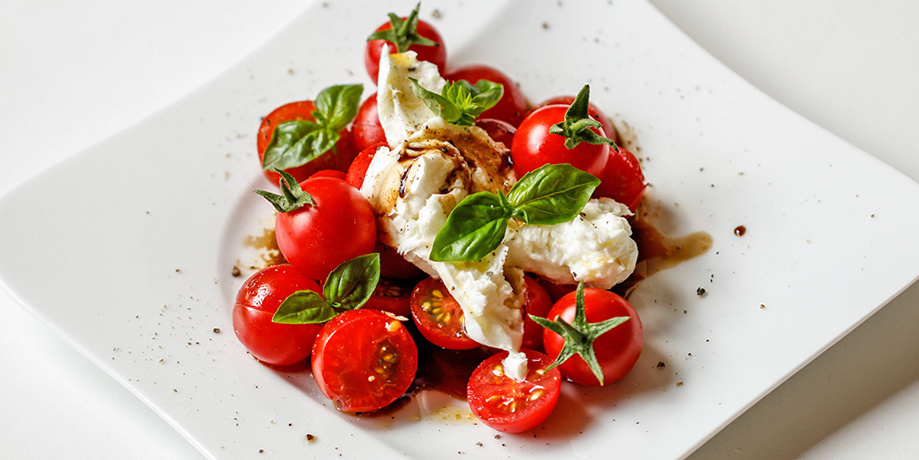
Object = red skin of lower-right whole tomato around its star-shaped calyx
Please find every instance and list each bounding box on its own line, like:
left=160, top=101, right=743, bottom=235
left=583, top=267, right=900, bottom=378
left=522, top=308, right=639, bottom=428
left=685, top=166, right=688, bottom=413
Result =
left=543, top=288, right=644, bottom=386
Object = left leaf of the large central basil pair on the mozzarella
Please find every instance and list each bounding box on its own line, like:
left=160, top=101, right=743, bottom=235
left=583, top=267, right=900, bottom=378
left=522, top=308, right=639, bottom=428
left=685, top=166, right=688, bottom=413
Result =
left=430, top=192, right=512, bottom=261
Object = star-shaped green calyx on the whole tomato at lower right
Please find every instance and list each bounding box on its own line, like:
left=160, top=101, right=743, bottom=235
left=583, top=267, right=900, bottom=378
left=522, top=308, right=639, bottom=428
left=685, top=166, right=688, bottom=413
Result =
left=529, top=281, right=631, bottom=386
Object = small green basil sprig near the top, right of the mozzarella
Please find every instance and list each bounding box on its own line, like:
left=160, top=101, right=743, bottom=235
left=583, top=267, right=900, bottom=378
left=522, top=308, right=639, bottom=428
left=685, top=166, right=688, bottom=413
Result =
left=409, top=77, right=504, bottom=126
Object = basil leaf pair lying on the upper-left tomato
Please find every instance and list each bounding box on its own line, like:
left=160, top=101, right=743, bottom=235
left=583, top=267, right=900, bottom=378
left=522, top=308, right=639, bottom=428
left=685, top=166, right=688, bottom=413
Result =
left=262, top=83, right=364, bottom=171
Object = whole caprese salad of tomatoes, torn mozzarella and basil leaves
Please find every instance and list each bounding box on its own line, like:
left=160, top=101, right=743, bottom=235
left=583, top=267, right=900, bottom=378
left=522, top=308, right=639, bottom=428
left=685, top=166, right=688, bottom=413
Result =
left=233, top=5, right=646, bottom=432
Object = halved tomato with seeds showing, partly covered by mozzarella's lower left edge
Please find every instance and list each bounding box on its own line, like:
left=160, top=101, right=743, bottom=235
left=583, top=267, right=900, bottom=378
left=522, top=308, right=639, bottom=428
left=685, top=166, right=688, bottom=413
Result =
left=411, top=278, right=479, bottom=350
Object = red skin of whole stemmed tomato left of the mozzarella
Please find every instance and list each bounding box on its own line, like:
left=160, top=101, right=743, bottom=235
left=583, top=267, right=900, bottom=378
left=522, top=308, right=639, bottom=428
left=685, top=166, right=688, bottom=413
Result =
left=275, top=177, right=377, bottom=281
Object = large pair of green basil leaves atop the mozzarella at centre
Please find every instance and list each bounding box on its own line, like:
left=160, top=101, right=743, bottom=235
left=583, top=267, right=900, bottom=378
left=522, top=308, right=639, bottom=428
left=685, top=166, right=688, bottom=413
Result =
left=430, top=164, right=600, bottom=262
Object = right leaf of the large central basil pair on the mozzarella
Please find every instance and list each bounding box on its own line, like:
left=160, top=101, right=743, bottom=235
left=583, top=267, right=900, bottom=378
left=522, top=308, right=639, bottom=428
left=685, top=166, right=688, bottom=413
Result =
left=507, top=164, right=600, bottom=225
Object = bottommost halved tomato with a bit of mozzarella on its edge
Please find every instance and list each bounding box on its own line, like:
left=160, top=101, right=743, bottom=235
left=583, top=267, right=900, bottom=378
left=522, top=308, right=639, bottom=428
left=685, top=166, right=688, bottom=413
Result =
left=466, top=350, right=562, bottom=433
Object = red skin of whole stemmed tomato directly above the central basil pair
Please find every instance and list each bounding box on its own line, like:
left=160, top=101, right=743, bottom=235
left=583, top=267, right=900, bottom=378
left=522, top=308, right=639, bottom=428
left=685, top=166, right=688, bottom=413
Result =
left=511, top=105, right=609, bottom=177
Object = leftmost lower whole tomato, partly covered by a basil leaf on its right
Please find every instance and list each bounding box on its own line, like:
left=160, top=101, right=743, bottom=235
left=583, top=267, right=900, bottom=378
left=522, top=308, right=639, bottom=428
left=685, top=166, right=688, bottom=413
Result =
left=233, top=265, right=322, bottom=366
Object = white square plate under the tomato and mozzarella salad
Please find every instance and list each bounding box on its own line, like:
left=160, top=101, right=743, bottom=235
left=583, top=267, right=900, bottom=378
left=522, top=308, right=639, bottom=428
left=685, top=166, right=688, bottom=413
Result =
left=0, top=0, right=919, bottom=458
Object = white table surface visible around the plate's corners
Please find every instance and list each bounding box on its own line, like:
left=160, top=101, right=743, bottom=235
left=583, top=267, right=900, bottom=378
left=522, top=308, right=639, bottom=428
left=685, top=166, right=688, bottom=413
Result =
left=0, top=0, right=919, bottom=459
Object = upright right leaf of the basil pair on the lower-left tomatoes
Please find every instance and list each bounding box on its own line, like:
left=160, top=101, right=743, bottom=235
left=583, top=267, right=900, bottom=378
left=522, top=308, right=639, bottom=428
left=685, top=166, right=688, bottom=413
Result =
left=322, top=253, right=380, bottom=310
